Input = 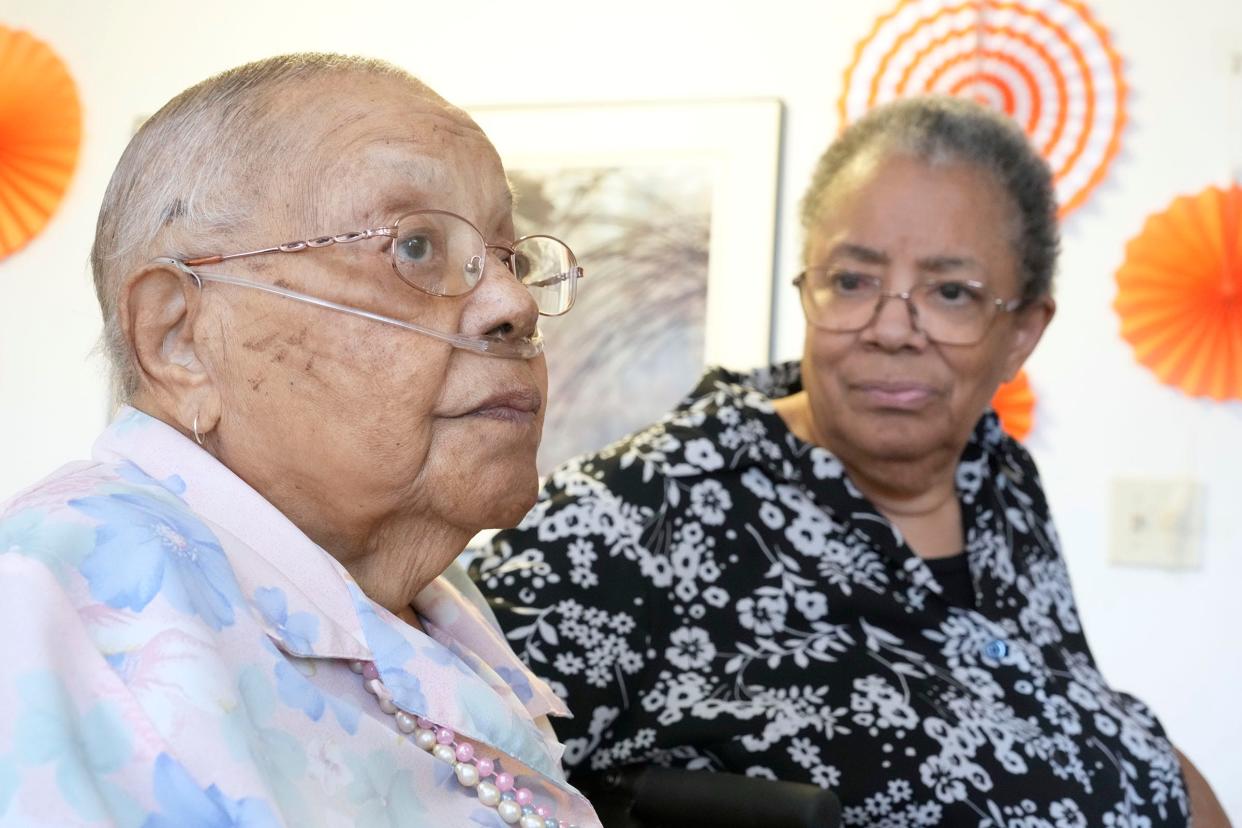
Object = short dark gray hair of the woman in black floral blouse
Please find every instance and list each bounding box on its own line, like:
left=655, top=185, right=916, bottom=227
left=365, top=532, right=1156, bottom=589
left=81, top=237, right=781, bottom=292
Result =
left=802, top=96, right=1061, bottom=300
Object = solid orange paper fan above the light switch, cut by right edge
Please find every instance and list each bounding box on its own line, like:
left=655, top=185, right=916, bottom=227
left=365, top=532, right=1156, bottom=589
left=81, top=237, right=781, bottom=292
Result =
left=1113, top=184, right=1242, bottom=400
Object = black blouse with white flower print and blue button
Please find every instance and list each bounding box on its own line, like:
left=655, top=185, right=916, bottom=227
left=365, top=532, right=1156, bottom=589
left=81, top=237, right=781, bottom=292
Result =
left=472, top=364, right=1187, bottom=828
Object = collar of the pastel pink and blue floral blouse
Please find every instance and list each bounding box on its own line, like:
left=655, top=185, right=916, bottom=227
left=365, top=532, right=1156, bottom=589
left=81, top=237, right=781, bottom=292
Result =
left=93, top=407, right=569, bottom=778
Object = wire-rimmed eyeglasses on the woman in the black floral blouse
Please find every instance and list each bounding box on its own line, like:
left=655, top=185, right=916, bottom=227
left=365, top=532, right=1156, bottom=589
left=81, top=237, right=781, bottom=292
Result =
left=794, top=267, right=1023, bottom=345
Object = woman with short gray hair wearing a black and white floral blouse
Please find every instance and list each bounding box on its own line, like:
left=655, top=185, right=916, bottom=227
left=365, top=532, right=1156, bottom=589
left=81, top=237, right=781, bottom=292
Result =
left=472, top=99, right=1220, bottom=828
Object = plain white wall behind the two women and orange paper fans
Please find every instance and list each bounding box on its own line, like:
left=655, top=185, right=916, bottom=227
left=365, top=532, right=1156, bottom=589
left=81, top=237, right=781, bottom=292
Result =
left=0, top=0, right=1242, bottom=819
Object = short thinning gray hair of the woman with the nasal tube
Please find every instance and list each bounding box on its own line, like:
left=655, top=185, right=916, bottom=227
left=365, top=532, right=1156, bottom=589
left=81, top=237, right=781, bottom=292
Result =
left=91, top=52, right=447, bottom=401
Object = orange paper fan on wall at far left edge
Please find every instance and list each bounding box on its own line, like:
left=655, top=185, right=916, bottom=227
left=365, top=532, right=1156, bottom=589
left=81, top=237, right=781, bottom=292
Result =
left=0, top=26, right=82, bottom=258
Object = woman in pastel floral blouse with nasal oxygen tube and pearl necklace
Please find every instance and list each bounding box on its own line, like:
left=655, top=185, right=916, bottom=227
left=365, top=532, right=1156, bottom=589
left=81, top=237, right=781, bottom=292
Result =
left=0, top=55, right=599, bottom=828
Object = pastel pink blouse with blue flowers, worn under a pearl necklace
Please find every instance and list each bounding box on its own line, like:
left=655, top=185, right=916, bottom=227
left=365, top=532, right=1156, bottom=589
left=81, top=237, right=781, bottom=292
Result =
left=0, top=408, right=599, bottom=828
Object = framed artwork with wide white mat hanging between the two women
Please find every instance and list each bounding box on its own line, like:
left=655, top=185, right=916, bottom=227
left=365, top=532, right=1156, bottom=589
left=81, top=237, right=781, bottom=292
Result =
left=469, top=99, right=781, bottom=474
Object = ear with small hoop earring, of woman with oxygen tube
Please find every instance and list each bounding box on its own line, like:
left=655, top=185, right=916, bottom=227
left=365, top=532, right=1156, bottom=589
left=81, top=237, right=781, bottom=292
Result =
left=117, top=262, right=220, bottom=434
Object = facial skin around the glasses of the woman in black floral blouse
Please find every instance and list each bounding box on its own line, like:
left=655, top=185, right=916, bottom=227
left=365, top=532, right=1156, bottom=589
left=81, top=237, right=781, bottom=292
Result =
left=802, top=154, right=1053, bottom=462
